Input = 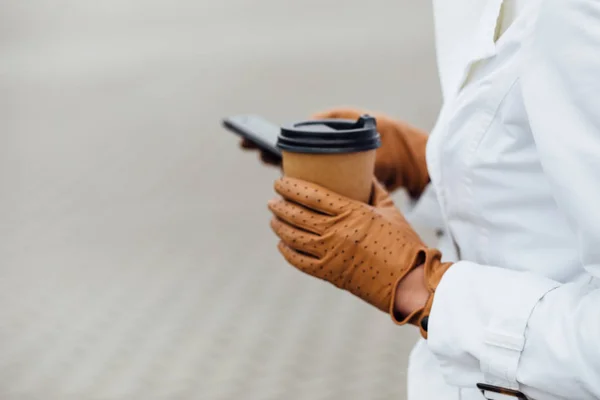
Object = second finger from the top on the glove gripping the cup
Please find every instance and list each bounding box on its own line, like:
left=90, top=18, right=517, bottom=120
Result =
left=268, top=198, right=337, bottom=235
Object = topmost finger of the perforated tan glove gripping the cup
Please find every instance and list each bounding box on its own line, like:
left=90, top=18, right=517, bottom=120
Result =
left=275, top=177, right=360, bottom=216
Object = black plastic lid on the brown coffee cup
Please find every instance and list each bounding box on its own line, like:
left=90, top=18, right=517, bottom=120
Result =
left=277, top=115, right=381, bottom=154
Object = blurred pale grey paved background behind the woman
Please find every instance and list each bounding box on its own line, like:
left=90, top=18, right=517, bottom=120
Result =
left=0, top=0, right=440, bottom=400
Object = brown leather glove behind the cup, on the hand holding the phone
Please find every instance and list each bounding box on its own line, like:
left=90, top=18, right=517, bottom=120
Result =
left=313, top=108, right=429, bottom=198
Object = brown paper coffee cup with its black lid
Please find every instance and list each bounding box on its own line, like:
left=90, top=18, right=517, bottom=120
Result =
left=277, top=115, right=381, bottom=203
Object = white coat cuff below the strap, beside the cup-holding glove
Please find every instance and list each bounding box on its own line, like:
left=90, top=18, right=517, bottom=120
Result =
left=428, top=261, right=559, bottom=390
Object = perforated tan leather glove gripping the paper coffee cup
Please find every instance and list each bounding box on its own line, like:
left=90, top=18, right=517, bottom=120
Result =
left=269, top=177, right=450, bottom=337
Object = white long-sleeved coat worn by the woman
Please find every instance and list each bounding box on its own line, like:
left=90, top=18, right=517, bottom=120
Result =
left=409, top=0, right=600, bottom=400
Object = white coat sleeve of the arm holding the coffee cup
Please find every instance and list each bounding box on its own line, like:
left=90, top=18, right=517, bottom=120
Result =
left=428, top=0, right=600, bottom=399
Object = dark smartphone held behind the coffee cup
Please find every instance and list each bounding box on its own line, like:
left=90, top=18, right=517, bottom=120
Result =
left=223, top=115, right=281, bottom=158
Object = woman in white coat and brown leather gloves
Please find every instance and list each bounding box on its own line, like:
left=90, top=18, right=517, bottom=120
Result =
left=241, top=0, right=600, bottom=400
